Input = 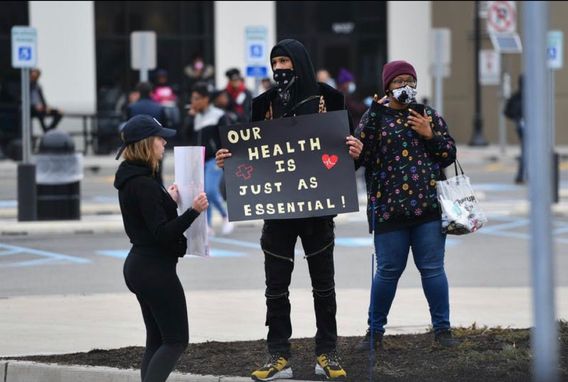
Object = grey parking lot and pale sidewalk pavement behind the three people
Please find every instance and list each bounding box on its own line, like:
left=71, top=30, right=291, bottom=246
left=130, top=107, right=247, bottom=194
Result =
left=0, top=146, right=568, bottom=381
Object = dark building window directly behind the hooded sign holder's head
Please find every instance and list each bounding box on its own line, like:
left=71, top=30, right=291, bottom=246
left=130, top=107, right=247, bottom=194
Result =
left=276, top=1, right=387, bottom=98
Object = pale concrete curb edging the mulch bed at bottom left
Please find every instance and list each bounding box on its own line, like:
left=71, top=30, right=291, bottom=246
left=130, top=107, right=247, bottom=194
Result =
left=0, top=360, right=310, bottom=382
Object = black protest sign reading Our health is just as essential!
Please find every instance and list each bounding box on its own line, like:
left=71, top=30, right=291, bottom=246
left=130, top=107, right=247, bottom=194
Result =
left=219, top=110, right=359, bottom=221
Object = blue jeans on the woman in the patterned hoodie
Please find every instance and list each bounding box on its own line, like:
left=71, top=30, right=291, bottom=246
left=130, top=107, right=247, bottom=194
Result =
left=368, top=220, right=450, bottom=333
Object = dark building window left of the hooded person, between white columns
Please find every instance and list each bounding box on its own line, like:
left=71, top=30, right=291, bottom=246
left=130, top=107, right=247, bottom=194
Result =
left=95, top=1, right=214, bottom=110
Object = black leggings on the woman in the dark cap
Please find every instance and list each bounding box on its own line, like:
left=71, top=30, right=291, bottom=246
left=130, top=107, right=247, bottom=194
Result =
left=124, top=252, right=189, bottom=382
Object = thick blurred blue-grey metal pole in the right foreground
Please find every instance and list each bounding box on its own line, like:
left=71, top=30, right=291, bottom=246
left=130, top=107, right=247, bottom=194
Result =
left=523, top=1, right=559, bottom=382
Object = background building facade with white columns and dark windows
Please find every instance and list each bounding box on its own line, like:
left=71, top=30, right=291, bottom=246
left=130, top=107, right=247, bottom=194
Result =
left=0, top=1, right=568, bottom=144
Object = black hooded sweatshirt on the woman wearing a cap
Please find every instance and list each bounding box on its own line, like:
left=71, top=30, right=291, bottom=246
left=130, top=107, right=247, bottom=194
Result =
left=114, top=161, right=199, bottom=261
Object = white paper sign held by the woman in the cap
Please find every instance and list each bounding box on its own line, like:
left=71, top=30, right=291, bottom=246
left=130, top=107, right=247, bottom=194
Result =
left=174, top=146, right=209, bottom=256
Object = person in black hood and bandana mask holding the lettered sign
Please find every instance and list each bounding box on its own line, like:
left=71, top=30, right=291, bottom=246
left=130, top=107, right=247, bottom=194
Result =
left=216, top=39, right=362, bottom=381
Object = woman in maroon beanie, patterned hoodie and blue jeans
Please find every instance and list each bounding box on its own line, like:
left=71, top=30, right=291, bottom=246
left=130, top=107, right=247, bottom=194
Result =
left=356, top=61, right=456, bottom=351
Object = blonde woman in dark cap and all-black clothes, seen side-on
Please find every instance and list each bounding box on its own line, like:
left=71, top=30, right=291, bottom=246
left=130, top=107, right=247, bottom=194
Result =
left=114, top=115, right=208, bottom=382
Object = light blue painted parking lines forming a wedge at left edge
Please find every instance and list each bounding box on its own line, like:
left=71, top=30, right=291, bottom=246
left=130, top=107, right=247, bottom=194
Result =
left=0, top=244, right=91, bottom=268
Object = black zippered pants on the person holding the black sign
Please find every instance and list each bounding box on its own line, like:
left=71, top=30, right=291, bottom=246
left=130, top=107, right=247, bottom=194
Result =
left=260, top=217, right=337, bottom=357
